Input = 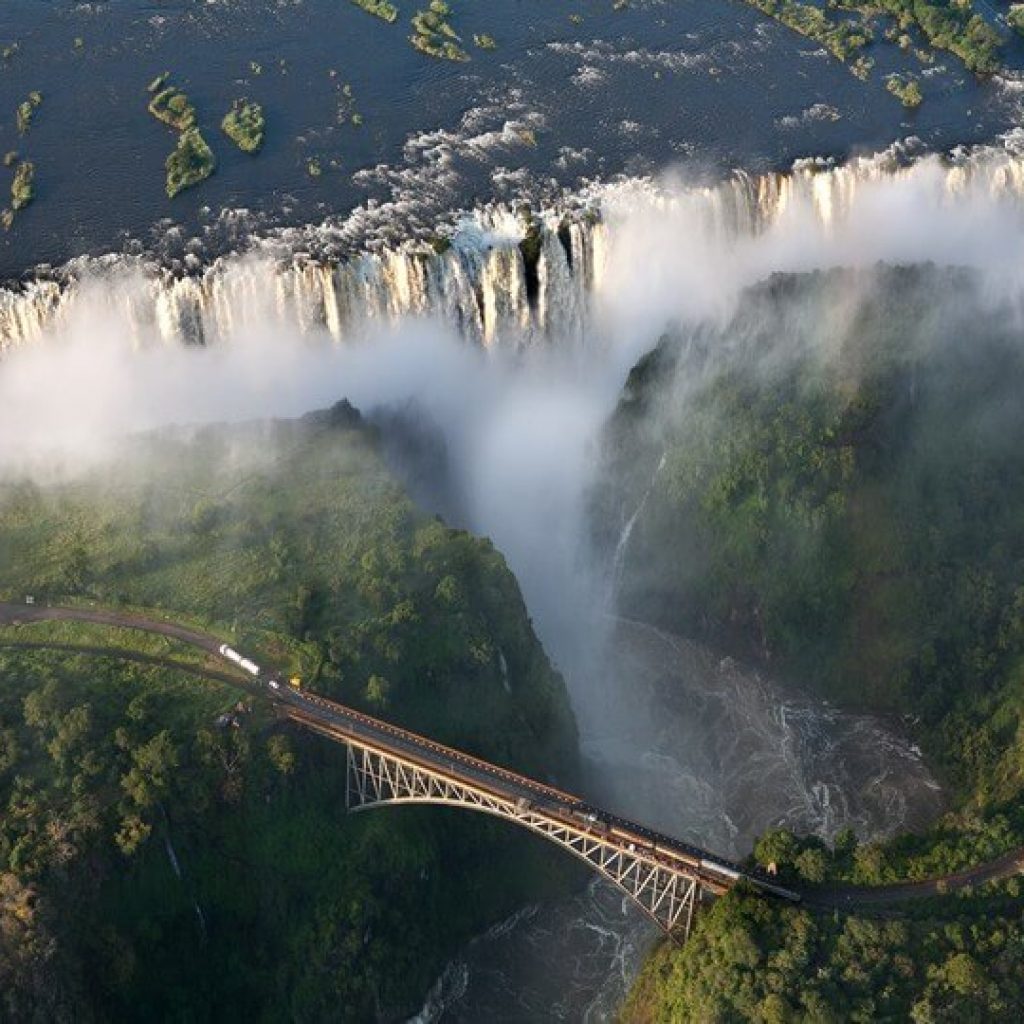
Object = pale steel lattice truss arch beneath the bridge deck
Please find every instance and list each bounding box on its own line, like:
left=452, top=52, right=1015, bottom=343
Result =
left=346, top=739, right=706, bottom=938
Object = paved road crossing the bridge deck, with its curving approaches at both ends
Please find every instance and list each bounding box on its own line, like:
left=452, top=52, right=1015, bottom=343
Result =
left=0, top=602, right=1024, bottom=910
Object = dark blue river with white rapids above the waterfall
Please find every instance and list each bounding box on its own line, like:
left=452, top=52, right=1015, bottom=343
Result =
left=6, top=0, right=1024, bottom=276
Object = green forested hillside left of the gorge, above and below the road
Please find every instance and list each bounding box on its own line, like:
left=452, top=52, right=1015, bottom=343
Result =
left=0, top=406, right=577, bottom=1021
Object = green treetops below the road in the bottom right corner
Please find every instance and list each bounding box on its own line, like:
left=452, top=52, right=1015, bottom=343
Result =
left=622, top=881, right=1024, bottom=1024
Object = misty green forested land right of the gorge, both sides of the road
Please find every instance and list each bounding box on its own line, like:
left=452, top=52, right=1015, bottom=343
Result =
left=594, top=267, right=1024, bottom=1021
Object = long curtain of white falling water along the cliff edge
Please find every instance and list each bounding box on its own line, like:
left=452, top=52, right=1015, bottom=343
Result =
left=6, top=132, right=1024, bottom=356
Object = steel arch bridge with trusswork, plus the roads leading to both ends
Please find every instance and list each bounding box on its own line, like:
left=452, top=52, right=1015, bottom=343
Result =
left=0, top=602, right=1024, bottom=933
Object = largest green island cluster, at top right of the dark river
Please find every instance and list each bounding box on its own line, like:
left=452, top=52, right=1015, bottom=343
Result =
left=743, top=0, right=1013, bottom=85
